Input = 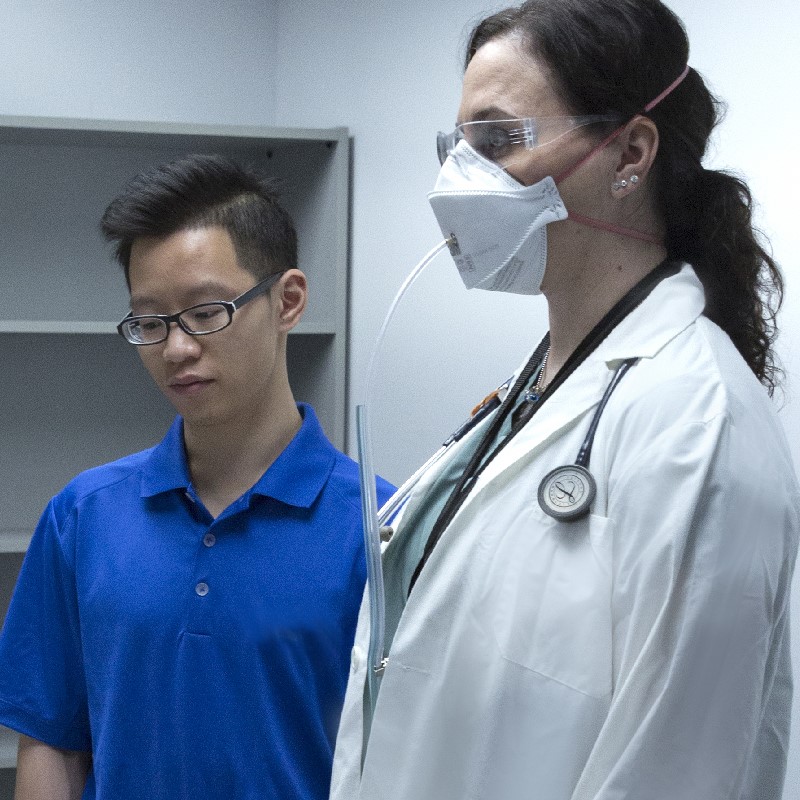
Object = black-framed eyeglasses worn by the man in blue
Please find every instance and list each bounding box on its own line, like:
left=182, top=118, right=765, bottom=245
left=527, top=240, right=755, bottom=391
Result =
left=117, top=270, right=286, bottom=346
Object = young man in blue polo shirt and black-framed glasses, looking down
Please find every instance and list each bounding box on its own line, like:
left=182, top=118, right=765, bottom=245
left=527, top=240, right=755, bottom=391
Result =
left=0, top=156, right=390, bottom=800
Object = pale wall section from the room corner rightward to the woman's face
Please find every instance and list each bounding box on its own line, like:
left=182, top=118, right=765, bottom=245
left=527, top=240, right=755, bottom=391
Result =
left=276, top=0, right=545, bottom=481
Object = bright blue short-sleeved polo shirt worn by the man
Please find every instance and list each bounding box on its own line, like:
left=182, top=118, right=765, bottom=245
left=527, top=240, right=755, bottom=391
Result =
left=0, top=405, right=391, bottom=800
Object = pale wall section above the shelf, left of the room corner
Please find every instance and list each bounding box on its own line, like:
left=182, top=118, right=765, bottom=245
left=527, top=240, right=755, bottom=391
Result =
left=0, top=0, right=277, bottom=125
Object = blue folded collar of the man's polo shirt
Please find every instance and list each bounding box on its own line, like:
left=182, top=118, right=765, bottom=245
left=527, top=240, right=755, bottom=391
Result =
left=141, top=403, right=336, bottom=508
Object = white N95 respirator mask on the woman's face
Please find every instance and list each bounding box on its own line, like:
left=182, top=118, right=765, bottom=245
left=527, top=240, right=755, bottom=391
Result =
left=428, top=139, right=567, bottom=294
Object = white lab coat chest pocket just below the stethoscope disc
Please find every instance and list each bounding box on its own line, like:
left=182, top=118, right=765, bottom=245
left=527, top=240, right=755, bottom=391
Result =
left=476, top=505, right=612, bottom=698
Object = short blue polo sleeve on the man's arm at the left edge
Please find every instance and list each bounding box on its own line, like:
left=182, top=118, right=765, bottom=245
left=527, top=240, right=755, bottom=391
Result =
left=0, top=500, right=91, bottom=751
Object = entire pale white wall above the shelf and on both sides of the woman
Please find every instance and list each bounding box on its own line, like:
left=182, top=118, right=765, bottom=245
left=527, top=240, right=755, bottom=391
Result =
left=0, top=0, right=800, bottom=800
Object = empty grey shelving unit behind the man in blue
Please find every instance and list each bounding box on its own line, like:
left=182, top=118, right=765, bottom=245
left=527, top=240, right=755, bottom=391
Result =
left=0, top=116, right=350, bottom=780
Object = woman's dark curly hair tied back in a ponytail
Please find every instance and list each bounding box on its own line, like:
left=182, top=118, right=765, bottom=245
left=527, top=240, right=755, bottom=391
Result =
left=466, top=0, right=783, bottom=394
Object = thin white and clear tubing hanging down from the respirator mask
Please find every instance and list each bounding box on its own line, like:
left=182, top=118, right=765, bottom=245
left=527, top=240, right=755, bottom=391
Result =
left=356, top=241, right=447, bottom=692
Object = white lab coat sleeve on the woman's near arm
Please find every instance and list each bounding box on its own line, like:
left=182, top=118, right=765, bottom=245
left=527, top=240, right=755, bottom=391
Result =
left=573, top=415, right=800, bottom=800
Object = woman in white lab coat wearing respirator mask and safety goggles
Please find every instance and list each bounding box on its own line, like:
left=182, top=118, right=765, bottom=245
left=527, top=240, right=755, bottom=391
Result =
left=332, top=0, right=800, bottom=800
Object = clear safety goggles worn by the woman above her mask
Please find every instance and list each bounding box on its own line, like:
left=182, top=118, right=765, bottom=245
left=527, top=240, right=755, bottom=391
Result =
left=436, top=114, right=623, bottom=167
